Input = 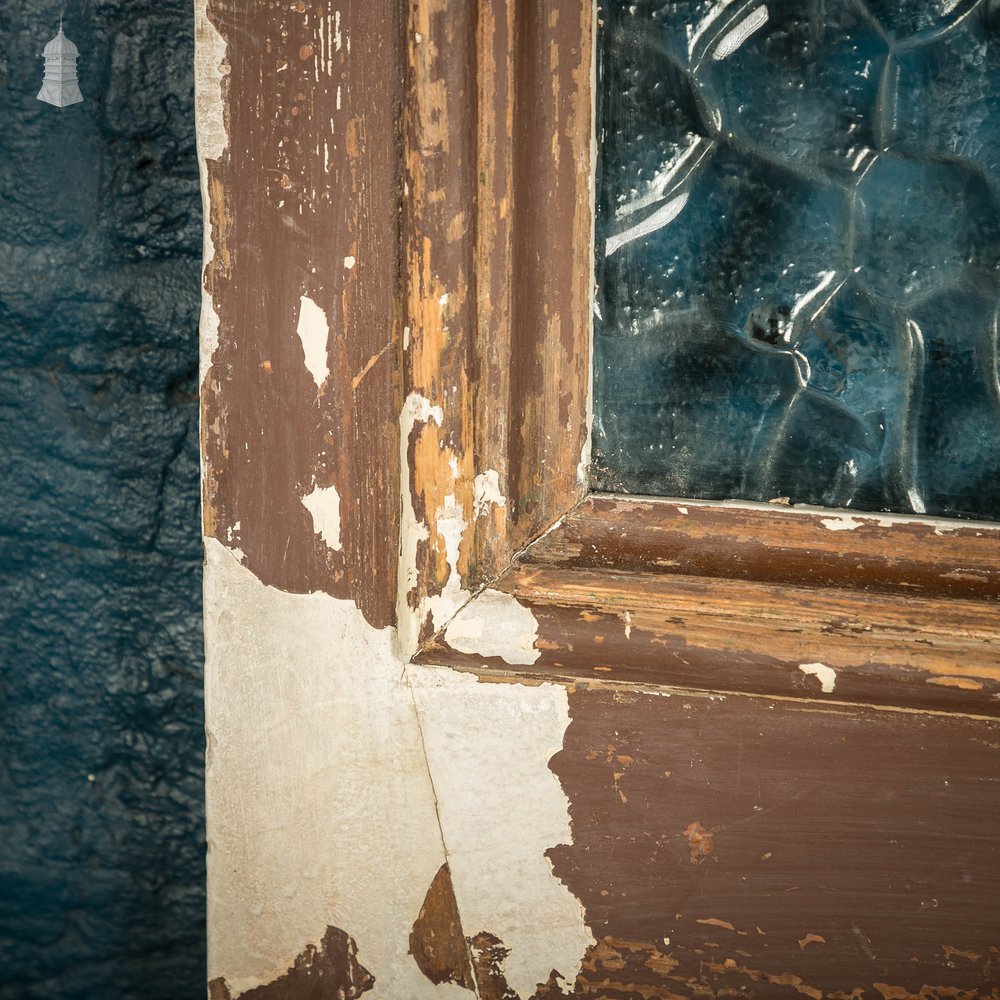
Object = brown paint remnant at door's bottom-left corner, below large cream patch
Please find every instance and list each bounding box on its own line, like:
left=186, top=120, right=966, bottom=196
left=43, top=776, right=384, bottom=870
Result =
left=208, top=927, right=375, bottom=1000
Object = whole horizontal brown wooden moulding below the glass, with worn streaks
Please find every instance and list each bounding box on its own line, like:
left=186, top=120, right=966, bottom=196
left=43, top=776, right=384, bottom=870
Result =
left=421, top=497, right=1000, bottom=716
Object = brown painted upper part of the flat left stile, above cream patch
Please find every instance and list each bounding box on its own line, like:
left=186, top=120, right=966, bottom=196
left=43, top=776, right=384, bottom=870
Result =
left=202, top=0, right=402, bottom=627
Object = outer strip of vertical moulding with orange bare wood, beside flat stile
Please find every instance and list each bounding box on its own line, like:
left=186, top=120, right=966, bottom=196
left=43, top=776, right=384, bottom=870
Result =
left=400, top=0, right=477, bottom=639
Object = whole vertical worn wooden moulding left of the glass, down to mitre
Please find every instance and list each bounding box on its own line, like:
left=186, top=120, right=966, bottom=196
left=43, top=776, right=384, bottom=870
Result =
left=400, top=0, right=592, bottom=649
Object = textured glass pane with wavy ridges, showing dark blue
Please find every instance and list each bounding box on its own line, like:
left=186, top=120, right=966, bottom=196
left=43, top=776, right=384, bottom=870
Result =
left=593, top=0, right=1000, bottom=519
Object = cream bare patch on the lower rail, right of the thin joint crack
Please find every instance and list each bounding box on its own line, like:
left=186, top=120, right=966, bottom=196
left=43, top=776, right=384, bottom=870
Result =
left=406, top=665, right=594, bottom=997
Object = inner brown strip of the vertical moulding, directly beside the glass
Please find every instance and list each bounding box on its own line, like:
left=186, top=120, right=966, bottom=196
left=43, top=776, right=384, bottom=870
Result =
left=508, top=0, right=593, bottom=551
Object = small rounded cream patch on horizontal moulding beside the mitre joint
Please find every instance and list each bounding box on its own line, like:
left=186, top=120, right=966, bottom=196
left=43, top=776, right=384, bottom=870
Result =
left=444, top=590, right=541, bottom=664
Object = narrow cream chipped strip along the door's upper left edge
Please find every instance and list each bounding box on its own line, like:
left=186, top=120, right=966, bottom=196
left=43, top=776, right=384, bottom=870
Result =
left=194, top=0, right=229, bottom=385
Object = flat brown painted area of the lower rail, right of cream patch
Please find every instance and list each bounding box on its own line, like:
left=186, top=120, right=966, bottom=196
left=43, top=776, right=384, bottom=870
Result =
left=547, top=685, right=1000, bottom=1000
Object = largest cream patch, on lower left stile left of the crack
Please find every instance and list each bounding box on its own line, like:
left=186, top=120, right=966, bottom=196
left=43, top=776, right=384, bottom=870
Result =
left=205, top=538, right=454, bottom=1000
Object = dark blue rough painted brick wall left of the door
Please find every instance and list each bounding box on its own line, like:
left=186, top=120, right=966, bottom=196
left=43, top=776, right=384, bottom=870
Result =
left=0, top=0, right=204, bottom=1000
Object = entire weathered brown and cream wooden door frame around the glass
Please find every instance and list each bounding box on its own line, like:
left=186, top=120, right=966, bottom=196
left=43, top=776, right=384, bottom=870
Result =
left=199, top=0, right=1000, bottom=1000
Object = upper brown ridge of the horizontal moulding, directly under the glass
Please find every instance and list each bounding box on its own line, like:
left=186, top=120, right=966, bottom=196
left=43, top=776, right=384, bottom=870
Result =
left=522, top=494, right=1000, bottom=601
